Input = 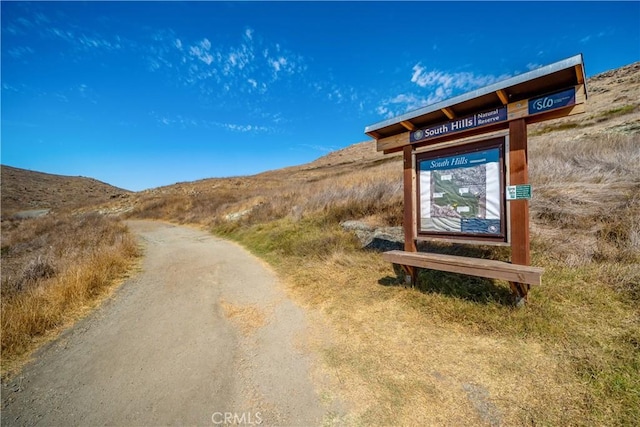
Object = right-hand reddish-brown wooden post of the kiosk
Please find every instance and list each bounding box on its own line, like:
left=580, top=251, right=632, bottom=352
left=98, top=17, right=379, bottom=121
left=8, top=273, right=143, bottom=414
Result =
left=508, top=119, right=531, bottom=301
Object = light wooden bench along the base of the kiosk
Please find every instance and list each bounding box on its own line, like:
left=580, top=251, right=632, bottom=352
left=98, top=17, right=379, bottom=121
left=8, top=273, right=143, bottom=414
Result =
left=382, top=251, right=544, bottom=300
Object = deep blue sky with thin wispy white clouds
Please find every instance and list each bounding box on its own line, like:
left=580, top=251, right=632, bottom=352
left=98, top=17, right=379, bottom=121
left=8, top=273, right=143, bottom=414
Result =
left=1, top=2, right=640, bottom=190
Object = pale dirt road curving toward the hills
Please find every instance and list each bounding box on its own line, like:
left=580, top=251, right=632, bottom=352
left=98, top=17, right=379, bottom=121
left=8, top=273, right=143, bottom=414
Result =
left=2, top=221, right=341, bottom=426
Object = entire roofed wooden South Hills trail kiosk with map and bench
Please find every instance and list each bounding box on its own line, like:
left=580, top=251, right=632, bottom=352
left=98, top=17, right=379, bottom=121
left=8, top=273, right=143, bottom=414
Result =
left=365, top=54, right=587, bottom=303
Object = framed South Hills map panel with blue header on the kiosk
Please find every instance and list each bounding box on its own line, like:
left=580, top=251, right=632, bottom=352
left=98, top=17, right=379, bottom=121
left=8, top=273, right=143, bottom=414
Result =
left=416, top=138, right=506, bottom=241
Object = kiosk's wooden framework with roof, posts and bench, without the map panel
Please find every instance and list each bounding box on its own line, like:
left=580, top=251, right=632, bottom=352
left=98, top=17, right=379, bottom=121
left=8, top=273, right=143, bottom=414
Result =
left=365, top=55, right=587, bottom=302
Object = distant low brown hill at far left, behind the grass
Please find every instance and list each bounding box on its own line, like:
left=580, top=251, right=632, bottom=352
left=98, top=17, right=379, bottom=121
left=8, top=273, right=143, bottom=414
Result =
left=0, top=165, right=130, bottom=217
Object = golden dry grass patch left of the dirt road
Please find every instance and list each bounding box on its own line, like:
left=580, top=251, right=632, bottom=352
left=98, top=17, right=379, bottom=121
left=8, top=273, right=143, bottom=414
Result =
left=1, top=214, right=139, bottom=375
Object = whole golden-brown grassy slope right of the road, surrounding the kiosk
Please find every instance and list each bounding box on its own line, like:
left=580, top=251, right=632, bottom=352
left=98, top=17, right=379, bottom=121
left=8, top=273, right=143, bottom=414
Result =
left=126, top=65, right=640, bottom=426
